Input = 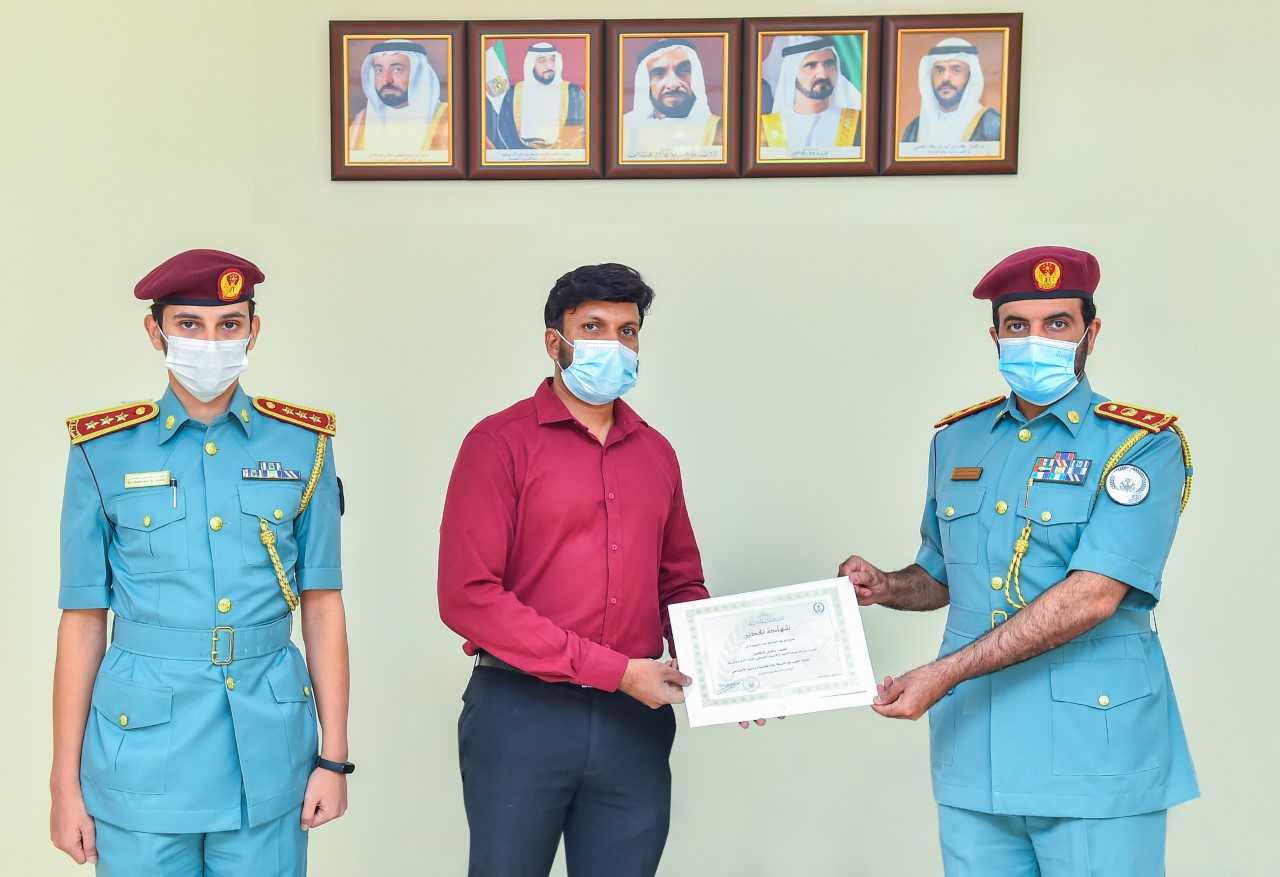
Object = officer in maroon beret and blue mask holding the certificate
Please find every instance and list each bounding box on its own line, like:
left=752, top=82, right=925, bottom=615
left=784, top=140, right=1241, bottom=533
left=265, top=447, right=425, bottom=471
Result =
left=840, top=247, right=1198, bottom=877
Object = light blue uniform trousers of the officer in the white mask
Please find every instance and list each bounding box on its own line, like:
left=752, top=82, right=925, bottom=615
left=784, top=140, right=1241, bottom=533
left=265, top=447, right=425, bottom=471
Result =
left=96, top=804, right=307, bottom=877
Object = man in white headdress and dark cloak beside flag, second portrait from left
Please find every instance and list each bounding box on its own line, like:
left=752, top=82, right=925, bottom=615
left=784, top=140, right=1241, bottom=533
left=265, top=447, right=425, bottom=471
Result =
left=484, top=37, right=588, bottom=163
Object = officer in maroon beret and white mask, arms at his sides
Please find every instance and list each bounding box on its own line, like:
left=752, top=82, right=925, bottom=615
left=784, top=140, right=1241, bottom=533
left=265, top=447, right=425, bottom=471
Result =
left=50, top=250, right=353, bottom=876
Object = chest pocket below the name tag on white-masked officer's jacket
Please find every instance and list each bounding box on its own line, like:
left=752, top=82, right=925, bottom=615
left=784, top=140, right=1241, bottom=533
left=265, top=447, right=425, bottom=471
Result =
left=111, top=488, right=189, bottom=574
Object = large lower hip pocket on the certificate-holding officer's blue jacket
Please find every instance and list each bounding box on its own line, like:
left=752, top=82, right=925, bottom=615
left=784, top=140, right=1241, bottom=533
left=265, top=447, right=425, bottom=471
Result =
left=1050, top=658, right=1169, bottom=776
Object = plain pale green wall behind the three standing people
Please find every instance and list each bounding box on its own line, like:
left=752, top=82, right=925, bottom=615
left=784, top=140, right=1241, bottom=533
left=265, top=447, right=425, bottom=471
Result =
left=0, top=0, right=1280, bottom=877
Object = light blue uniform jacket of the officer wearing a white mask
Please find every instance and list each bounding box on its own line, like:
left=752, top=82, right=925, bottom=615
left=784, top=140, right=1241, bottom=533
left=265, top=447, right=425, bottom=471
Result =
left=58, top=388, right=342, bottom=832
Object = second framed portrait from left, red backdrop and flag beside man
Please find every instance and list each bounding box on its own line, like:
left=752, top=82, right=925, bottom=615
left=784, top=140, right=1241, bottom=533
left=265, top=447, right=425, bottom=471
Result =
left=467, top=22, right=604, bottom=179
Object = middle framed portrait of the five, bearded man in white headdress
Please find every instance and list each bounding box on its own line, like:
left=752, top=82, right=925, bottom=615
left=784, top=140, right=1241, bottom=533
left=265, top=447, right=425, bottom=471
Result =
left=605, top=18, right=742, bottom=177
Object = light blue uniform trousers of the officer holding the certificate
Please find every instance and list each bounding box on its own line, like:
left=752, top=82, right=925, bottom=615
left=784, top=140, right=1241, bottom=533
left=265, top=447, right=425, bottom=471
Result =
left=938, top=804, right=1169, bottom=877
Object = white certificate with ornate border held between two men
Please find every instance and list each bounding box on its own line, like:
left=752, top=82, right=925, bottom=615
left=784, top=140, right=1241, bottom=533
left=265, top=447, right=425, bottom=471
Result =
left=668, top=579, right=876, bottom=727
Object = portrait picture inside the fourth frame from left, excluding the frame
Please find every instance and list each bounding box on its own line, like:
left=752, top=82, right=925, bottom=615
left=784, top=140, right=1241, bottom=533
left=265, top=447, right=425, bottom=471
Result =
left=756, top=33, right=863, bottom=161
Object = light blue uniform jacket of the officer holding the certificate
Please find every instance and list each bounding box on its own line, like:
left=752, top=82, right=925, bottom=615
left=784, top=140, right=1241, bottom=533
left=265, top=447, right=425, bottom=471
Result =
left=916, top=380, right=1199, bottom=817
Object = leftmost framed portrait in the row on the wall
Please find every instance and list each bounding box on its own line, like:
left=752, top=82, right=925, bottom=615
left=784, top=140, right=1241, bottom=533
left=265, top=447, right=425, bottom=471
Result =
left=329, top=22, right=467, bottom=179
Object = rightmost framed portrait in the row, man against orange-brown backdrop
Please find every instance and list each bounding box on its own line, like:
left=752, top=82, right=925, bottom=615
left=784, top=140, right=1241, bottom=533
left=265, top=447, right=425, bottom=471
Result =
left=881, top=13, right=1023, bottom=174
